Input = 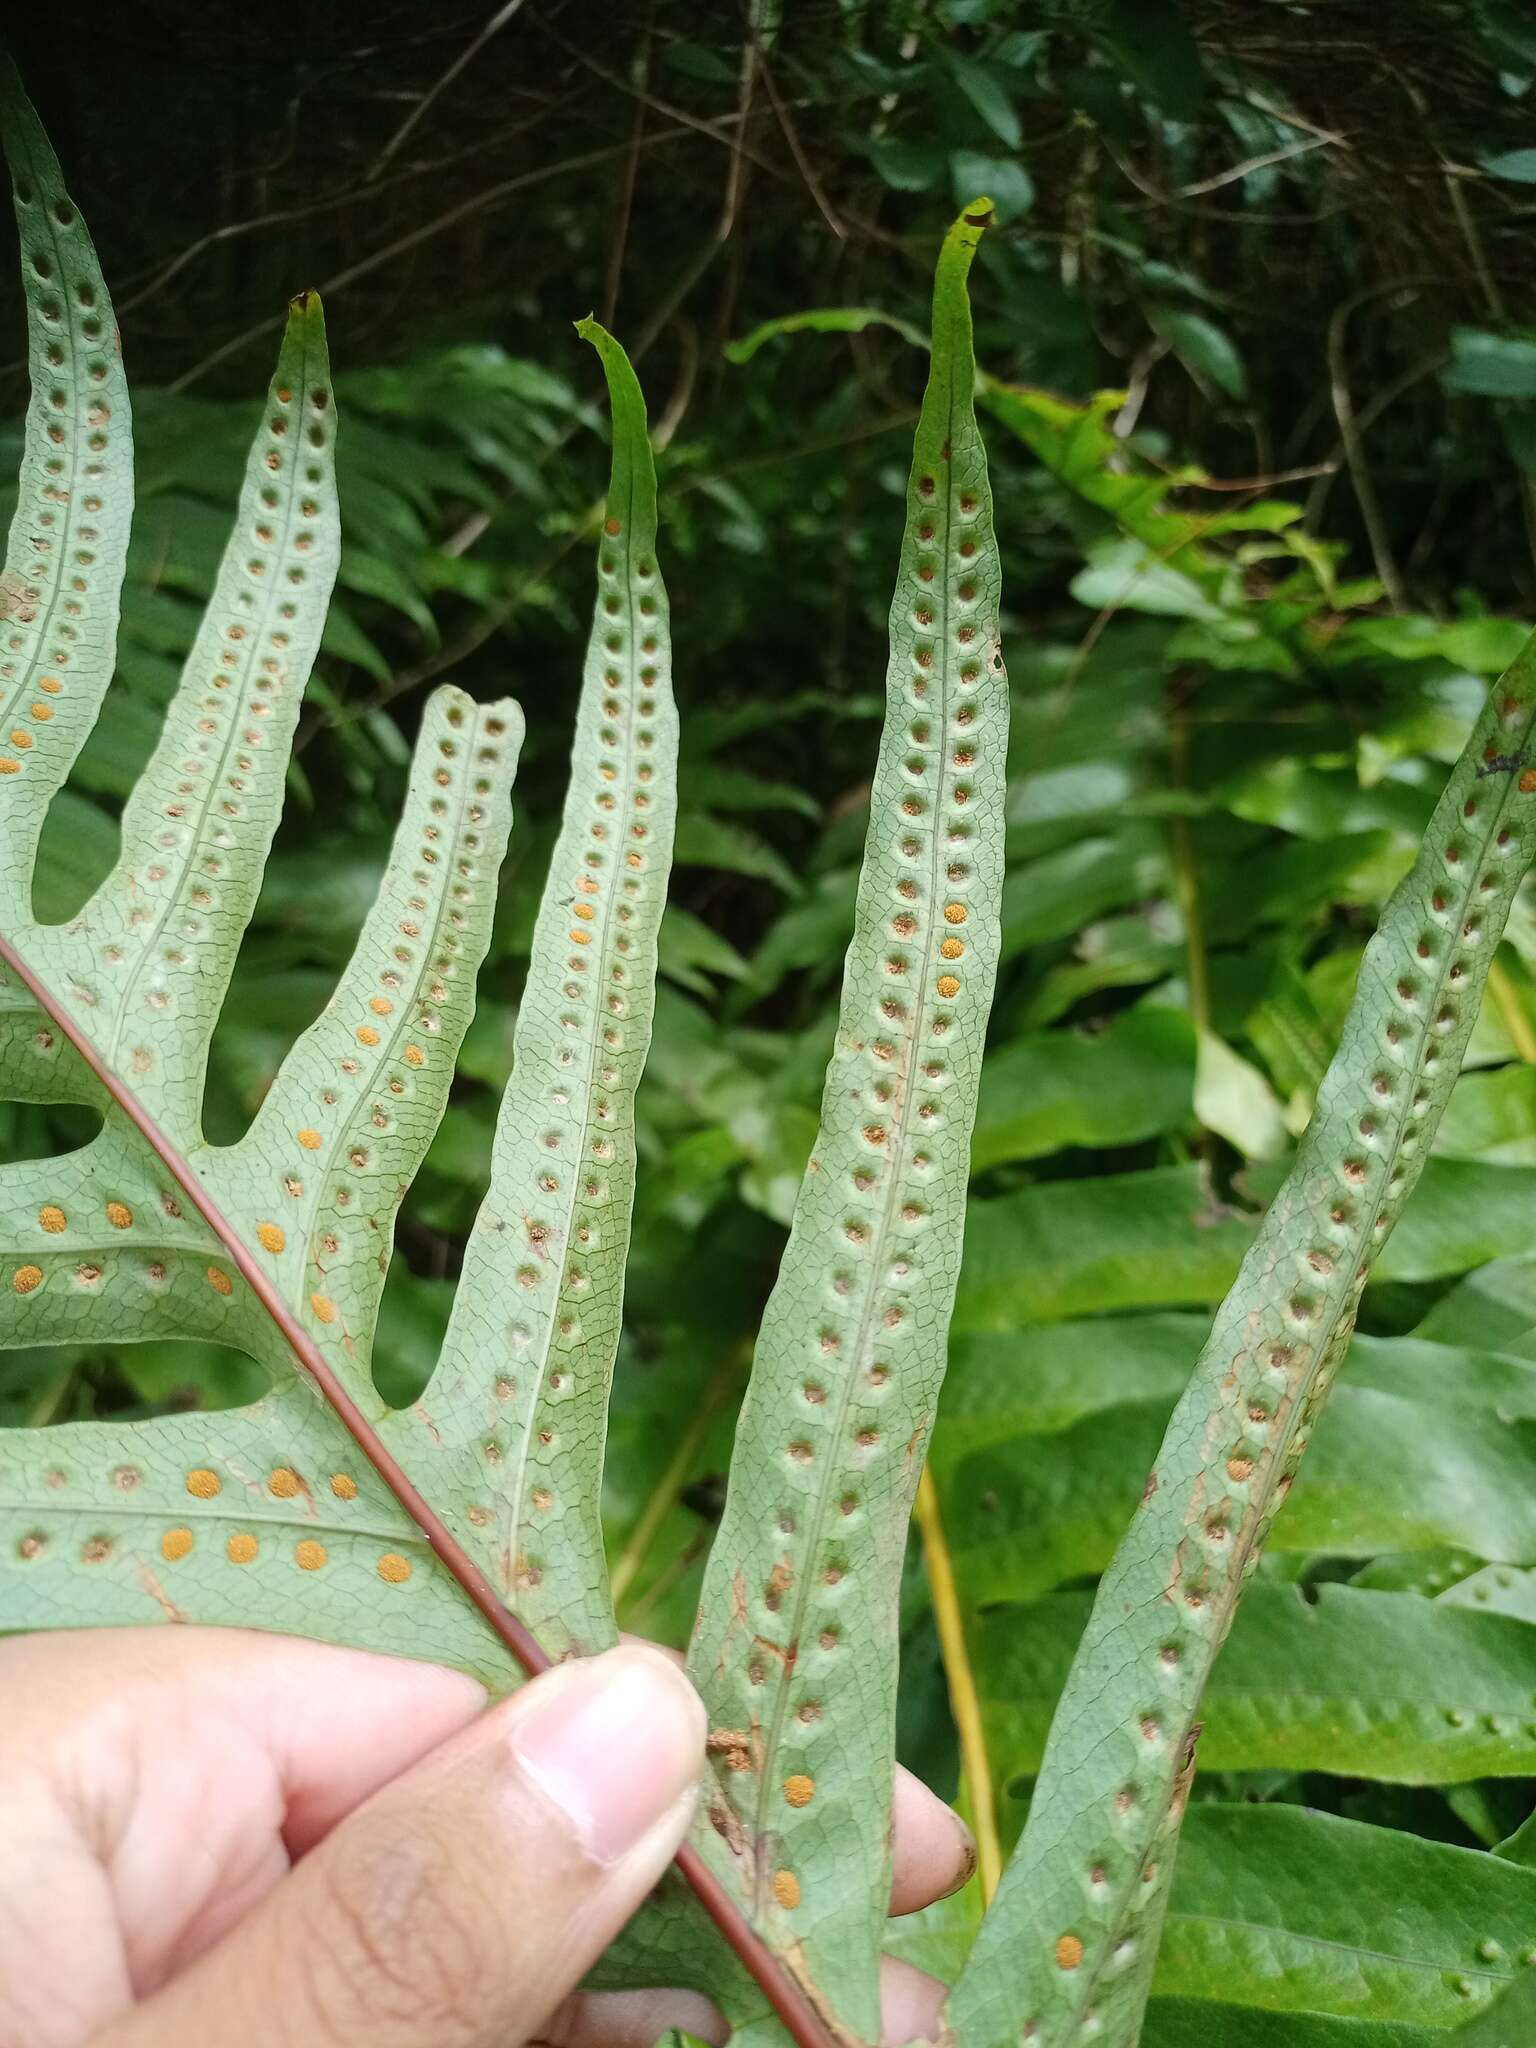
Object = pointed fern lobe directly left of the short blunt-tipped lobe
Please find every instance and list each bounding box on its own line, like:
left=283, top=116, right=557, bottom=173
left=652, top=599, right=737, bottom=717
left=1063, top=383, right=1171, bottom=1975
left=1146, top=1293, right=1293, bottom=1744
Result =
left=12, top=295, right=340, bottom=1143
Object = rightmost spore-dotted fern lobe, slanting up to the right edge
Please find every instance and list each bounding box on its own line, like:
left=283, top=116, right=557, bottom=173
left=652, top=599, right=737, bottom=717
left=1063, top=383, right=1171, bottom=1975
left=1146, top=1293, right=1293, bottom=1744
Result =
left=948, top=639, right=1536, bottom=2048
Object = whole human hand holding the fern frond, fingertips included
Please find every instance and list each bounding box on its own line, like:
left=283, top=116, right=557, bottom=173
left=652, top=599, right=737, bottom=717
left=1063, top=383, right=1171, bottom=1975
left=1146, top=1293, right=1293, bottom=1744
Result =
left=0, top=1628, right=973, bottom=2048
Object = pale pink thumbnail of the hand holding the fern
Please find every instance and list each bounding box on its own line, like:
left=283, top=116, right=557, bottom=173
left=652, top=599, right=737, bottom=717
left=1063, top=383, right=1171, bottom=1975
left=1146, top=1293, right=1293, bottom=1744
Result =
left=512, top=1647, right=705, bottom=1864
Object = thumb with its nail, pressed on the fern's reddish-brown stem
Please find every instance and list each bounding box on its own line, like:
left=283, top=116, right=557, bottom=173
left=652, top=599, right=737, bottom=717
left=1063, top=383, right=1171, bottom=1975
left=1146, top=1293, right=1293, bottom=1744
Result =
left=96, top=1647, right=705, bottom=2048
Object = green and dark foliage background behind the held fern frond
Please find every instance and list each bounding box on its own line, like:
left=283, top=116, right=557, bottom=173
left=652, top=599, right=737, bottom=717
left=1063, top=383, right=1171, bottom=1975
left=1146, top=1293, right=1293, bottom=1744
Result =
left=0, top=0, right=1536, bottom=2048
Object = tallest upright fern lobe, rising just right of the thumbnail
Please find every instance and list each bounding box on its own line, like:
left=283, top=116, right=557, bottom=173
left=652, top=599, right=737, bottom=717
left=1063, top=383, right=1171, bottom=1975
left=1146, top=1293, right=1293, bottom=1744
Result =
left=690, top=201, right=1008, bottom=2040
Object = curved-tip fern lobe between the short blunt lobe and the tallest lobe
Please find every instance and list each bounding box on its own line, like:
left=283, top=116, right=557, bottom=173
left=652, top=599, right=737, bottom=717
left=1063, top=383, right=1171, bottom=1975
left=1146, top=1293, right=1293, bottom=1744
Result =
left=403, top=322, right=678, bottom=1653
